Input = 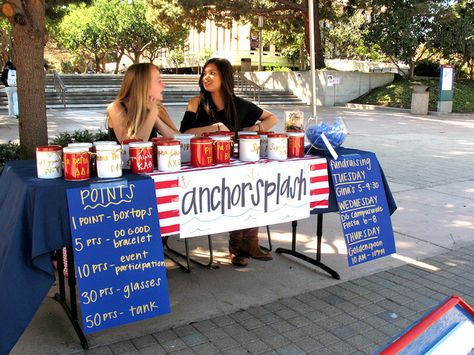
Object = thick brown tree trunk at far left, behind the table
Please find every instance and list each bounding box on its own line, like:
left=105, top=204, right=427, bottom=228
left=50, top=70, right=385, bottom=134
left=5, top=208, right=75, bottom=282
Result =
left=12, top=0, right=48, bottom=159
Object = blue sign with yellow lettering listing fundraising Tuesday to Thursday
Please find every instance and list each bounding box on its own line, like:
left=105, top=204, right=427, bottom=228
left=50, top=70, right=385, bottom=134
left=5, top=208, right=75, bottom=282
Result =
left=329, top=153, right=395, bottom=266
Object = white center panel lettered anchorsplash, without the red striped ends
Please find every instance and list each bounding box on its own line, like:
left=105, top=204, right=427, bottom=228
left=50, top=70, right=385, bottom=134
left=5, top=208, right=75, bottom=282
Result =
left=179, top=160, right=310, bottom=238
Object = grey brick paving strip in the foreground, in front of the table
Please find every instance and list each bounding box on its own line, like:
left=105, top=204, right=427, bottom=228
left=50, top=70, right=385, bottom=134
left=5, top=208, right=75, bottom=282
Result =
left=75, top=245, right=474, bottom=355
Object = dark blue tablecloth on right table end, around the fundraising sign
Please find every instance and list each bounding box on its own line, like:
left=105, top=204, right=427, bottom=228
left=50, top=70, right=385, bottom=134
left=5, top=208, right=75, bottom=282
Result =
left=309, top=147, right=397, bottom=214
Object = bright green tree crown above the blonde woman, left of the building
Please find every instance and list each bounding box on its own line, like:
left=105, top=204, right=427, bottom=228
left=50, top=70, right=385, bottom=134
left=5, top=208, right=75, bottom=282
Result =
left=58, top=0, right=172, bottom=71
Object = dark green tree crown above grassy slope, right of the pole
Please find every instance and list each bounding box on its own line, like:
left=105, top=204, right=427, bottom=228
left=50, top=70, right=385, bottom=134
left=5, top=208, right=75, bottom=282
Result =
left=365, top=0, right=445, bottom=78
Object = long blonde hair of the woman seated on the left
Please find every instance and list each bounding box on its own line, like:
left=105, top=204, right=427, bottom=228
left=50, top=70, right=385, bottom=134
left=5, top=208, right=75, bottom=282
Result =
left=110, top=63, right=159, bottom=138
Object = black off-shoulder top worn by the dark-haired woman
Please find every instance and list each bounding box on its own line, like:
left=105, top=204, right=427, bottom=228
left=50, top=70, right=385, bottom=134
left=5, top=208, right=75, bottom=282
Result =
left=179, top=96, right=263, bottom=133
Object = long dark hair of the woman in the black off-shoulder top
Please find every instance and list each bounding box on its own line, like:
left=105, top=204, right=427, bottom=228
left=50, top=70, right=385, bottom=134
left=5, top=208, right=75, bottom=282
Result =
left=198, top=58, right=239, bottom=131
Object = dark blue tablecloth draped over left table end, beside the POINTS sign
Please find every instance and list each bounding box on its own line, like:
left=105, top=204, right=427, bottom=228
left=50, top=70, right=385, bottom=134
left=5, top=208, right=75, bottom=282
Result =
left=0, top=160, right=148, bottom=354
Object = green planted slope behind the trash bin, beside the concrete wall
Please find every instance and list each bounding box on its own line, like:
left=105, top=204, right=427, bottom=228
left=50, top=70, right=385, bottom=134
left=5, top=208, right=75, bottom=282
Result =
left=352, top=79, right=474, bottom=112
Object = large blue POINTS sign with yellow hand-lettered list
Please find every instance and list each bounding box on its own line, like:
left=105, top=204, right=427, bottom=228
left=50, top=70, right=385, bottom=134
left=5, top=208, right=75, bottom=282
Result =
left=67, top=179, right=170, bottom=334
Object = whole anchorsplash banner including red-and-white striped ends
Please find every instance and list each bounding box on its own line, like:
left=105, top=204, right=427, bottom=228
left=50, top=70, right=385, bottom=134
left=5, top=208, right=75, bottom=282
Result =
left=150, top=158, right=329, bottom=238
